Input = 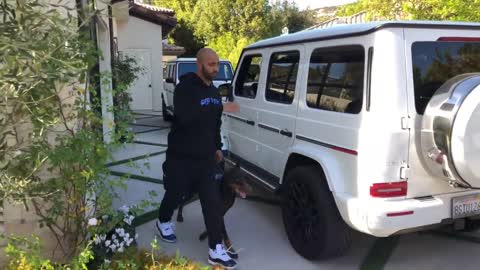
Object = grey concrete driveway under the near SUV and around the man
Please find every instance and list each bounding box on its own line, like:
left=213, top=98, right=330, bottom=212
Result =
left=109, top=112, right=480, bottom=270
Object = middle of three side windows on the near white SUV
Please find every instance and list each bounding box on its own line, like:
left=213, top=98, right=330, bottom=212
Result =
left=265, top=51, right=300, bottom=104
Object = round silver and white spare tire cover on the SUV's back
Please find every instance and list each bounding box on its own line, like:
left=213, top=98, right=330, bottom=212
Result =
left=420, top=73, right=480, bottom=187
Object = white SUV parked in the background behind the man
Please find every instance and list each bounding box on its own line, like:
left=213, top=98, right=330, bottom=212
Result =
left=162, top=58, right=233, bottom=121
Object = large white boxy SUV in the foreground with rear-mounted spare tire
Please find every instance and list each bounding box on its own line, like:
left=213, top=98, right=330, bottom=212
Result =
left=222, top=22, right=480, bottom=259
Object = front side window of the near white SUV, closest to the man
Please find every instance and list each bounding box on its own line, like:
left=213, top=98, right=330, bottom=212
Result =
left=235, top=55, right=262, bottom=99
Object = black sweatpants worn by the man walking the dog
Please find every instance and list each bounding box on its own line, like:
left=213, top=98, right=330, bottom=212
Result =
left=158, top=158, right=223, bottom=249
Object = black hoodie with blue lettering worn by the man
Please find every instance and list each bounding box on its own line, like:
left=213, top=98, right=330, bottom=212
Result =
left=167, top=73, right=223, bottom=161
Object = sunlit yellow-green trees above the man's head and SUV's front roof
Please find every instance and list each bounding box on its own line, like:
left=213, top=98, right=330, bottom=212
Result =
left=153, top=0, right=316, bottom=66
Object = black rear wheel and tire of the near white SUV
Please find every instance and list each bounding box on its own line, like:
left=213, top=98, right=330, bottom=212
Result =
left=282, top=166, right=351, bottom=260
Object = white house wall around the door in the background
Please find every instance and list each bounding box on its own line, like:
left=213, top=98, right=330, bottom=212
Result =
left=116, top=16, right=163, bottom=111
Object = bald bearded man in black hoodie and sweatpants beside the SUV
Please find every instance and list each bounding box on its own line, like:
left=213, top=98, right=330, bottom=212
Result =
left=155, top=48, right=238, bottom=269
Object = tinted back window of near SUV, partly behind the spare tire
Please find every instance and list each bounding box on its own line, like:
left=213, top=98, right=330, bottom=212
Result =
left=412, top=42, right=480, bottom=114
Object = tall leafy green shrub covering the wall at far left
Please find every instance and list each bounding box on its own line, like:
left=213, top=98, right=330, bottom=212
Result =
left=0, top=0, right=144, bottom=262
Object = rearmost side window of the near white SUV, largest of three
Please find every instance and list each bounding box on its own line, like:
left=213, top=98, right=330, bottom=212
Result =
left=307, top=46, right=365, bottom=114
